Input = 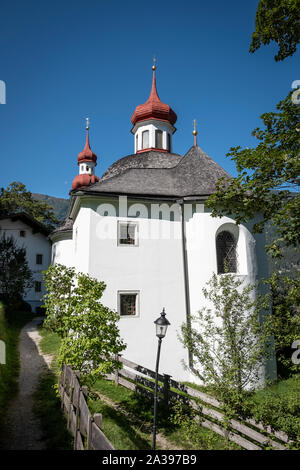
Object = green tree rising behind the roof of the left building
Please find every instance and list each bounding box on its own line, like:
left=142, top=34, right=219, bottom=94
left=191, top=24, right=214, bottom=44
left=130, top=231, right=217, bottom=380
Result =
left=0, top=181, right=58, bottom=229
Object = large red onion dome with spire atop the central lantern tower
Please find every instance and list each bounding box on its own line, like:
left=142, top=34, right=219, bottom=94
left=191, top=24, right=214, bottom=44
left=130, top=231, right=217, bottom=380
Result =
left=131, top=67, right=177, bottom=126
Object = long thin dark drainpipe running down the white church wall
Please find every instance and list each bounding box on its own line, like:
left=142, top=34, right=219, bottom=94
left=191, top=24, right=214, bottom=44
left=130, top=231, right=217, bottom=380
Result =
left=176, top=199, right=195, bottom=374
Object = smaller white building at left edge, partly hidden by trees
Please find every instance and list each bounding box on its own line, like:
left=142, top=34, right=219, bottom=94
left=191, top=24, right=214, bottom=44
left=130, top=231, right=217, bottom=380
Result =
left=0, top=213, right=51, bottom=311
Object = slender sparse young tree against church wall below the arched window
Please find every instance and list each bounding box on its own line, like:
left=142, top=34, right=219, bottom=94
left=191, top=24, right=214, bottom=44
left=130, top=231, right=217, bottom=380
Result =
left=180, top=273, right=270, bottom=414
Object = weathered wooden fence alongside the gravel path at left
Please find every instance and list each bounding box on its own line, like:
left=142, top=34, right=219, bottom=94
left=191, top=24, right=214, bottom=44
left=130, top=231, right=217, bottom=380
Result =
left=59, top=365, right=114, bottom=450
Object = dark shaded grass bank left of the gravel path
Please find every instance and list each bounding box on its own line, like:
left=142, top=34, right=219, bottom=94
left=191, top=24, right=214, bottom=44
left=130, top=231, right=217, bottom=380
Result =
left=0, top=303, right=36, bottom=447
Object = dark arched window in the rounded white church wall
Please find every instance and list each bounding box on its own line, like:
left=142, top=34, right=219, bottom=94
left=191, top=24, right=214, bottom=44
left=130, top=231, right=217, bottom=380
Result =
left=216, top=231, right=237, bottom=274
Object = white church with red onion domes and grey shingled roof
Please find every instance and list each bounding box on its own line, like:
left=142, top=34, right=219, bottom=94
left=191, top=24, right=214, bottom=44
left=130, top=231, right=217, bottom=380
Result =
left=51, top=66, right=276, bottom=381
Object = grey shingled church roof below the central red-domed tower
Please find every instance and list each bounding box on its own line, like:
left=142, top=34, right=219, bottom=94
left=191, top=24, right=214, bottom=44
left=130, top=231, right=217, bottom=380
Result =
left=81, top=146, right=231, bottom=197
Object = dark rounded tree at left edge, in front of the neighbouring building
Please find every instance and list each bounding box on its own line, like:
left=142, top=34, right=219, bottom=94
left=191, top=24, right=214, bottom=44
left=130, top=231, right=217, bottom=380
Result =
left=0, top=234, right=33, bottom=305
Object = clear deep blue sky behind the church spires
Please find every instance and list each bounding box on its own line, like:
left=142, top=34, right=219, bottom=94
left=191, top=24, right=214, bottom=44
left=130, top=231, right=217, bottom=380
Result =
left=0, top=0, right=300, bottom=197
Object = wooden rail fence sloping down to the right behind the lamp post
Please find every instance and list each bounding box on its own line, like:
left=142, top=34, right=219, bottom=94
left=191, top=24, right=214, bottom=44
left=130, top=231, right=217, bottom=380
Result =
left=106, top=356, right=290, bottom=450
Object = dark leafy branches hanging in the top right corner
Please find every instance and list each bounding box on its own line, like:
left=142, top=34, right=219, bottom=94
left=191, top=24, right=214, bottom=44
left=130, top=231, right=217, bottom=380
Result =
left=250, top=0, right=300, bottom=61
